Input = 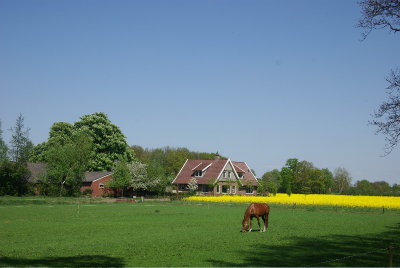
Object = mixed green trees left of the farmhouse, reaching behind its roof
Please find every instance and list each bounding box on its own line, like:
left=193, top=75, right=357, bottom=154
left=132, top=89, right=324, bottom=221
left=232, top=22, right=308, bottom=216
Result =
left=0, top=113, right=220, bottom=196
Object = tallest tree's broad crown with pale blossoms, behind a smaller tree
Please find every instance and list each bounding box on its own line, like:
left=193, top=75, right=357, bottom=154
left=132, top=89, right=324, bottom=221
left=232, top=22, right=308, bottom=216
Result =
left=30, top=113, right=134, bottom=171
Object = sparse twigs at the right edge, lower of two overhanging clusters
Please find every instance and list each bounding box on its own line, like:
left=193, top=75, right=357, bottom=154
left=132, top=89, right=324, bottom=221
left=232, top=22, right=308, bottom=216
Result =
left=370, top=70, right=400, bottom=155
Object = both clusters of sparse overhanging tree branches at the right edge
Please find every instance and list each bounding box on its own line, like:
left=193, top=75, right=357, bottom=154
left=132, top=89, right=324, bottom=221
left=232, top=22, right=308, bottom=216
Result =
left=357, top=0, right=400, bottom=155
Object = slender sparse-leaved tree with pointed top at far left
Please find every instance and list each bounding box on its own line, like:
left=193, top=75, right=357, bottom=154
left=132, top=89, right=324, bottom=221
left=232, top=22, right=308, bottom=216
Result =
left=9, top=114, right=33, bottom=164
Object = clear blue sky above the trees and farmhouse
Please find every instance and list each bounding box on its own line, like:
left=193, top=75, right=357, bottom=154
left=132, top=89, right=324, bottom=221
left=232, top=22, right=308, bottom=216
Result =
left=0, top=0, right=400, bottom=183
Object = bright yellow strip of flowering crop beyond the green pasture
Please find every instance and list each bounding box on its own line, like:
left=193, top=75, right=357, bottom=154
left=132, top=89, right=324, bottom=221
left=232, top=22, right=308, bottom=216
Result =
left=184, top=194, right=400, bottom=209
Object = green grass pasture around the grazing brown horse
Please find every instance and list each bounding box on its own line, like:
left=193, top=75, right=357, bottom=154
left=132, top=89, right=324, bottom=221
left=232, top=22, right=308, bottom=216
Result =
left=0, top=199, right=400, bottom=267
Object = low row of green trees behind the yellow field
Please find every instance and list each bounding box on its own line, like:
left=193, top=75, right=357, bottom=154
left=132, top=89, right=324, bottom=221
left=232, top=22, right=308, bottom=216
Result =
left=258, top=158, right=400, bottom=196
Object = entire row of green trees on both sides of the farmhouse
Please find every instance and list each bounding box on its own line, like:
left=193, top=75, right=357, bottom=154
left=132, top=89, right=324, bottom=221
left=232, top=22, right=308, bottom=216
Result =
left=0, top=113, right=400, bottom=196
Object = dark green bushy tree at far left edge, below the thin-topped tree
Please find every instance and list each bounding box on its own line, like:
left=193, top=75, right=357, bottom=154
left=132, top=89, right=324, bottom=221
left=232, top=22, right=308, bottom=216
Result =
left=0, top=161, right=29, bottom=196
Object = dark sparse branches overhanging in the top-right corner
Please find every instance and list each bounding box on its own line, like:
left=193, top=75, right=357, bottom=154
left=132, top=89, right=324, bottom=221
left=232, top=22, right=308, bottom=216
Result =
left=357, top=0, right=400, bottom=39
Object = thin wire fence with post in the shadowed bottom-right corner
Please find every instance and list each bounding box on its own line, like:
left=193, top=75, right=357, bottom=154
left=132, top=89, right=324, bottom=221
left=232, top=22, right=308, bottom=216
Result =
left=303, top=244, right=400, bottom=267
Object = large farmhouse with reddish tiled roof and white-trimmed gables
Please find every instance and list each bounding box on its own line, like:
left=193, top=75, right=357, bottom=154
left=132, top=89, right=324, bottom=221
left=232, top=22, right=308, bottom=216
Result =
left=172, top=159, right=258, bottom=195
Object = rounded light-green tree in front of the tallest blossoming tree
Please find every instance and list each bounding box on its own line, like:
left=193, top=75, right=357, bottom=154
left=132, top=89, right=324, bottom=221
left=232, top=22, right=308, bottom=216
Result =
left=46, top=131, right=93, bottom=196
